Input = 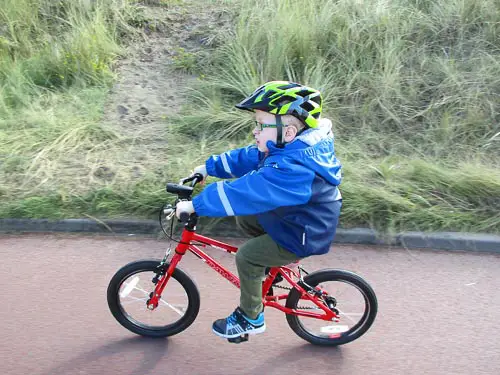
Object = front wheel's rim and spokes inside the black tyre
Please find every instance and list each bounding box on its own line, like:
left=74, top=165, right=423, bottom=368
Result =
left=117, top=270, right=189, bottom=330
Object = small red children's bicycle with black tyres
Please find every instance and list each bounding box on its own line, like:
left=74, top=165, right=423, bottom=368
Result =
left=107, top=174, right=377, bottom=346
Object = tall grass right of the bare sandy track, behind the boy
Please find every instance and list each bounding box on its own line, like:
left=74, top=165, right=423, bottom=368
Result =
left=173, top=0, right=500, bottom=232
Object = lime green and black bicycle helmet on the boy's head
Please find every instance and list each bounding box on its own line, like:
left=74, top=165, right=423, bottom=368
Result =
left=236, top=81, right=322, bottom=128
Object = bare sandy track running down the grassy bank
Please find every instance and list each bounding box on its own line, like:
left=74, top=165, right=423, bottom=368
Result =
left=104, top=1, right=234, bottom=178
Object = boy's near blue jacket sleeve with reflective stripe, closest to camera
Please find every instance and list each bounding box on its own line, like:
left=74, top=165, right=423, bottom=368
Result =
left=193, top=162, right=314, bottom=217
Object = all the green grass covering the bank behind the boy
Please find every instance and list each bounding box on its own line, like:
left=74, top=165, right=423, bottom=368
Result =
left=0, top=0, right=500, bottom=233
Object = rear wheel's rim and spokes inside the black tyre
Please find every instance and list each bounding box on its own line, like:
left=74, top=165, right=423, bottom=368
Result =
left=297, top=280, right=370, bottom=340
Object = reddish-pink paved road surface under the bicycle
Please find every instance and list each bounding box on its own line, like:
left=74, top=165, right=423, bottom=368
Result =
left=0, top=235, right=500, bottom=375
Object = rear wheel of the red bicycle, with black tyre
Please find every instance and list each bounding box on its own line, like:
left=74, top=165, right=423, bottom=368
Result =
left=286, top=269, right=378, bottom=346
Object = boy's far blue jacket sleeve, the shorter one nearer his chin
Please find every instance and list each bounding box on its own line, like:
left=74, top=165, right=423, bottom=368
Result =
left=205, top=146, right=263, bottom=178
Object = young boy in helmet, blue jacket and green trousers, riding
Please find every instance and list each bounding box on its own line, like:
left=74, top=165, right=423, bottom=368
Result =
left=176, top=81, right=342, bottom=338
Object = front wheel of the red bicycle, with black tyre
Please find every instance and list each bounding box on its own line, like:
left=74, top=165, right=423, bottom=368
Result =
left=107, top=260, right=200, bottom=337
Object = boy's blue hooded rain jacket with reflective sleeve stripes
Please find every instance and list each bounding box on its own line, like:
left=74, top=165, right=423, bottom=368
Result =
left=193, top=119, right=342, bottom=257
